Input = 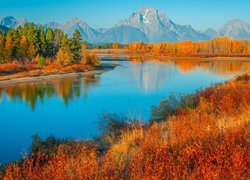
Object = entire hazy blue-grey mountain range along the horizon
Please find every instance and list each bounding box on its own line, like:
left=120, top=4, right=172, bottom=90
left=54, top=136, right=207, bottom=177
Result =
left=0, top=7, right=250, bottom=44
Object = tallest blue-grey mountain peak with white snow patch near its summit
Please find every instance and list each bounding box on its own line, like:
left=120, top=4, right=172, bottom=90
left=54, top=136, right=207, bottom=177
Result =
left=116, top=7, right=209, bottom=43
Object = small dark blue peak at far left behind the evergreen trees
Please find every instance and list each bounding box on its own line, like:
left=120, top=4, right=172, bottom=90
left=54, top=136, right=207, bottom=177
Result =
left=0, top=16, right=27, bottom=28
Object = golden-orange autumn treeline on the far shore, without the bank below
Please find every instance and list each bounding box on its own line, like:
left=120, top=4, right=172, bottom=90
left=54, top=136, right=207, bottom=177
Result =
left=125, top=37, right=250, bottom=56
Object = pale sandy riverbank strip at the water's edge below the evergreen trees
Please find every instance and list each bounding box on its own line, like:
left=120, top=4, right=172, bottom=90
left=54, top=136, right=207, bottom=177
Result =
left=0, top=64, right=117, bottom=87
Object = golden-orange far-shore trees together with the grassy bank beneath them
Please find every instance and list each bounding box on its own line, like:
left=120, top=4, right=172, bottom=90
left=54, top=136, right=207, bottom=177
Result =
left=89, top=37, right=250, bottom=60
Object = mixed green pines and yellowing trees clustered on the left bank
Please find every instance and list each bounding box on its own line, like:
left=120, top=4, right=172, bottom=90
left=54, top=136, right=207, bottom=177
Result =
left=0, top=23, right=99, bottom=66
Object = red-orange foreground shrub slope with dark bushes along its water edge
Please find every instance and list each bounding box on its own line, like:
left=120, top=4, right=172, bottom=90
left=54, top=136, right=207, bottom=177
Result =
left=0, top=74, right=250, bottom=179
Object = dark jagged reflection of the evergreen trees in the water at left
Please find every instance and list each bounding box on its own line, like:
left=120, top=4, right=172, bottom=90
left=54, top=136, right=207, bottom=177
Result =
left=0, top=75, right=100, bottom=111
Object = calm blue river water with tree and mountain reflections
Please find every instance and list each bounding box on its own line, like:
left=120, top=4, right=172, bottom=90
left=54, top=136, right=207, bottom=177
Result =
left=0, top=57, right=250, bottom=163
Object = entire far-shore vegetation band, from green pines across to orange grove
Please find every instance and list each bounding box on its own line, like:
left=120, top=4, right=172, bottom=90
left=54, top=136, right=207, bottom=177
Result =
left=0, top=23, right=250, bottom=84
